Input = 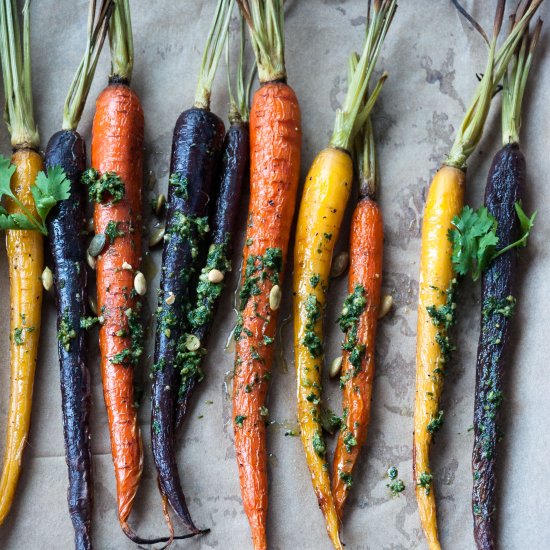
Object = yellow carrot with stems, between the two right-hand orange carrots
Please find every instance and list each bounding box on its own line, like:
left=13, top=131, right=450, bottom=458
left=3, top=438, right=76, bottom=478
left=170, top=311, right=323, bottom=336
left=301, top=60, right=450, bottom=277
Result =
left=293, top=4, right=397, bottom=548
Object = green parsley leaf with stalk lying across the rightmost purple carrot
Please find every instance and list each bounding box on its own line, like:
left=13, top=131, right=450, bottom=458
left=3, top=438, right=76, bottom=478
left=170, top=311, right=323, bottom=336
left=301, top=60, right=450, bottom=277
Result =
left=448, top=202, right=537, bottom=281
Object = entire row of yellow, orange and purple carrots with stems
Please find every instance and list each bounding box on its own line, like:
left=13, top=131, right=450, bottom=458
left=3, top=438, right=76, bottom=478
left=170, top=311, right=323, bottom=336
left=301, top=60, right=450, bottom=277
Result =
left=0, top=0, right=543, bottom=550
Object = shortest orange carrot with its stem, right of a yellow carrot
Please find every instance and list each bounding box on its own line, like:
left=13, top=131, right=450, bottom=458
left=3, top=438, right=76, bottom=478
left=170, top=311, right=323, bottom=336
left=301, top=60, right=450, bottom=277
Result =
left=332, top=106, right=384, bottom=518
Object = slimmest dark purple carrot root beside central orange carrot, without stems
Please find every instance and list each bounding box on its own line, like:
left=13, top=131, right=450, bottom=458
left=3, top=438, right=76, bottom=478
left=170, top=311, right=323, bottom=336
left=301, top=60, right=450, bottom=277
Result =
left=176, top=121, right=250, bottom=429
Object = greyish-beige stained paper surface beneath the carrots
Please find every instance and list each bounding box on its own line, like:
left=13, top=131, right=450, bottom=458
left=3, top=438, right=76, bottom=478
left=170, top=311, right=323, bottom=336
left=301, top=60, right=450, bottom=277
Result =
left=0, top=0, right=550, bottom=550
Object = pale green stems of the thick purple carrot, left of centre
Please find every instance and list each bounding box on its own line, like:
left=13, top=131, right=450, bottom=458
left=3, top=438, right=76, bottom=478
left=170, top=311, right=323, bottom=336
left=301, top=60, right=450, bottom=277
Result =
left=194, top=0, right=235, bottom=110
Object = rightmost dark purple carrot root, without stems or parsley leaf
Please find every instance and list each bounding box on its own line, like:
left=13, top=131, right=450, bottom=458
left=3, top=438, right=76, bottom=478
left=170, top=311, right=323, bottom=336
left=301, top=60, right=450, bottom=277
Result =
left=472, top=143, right=526, bottom=550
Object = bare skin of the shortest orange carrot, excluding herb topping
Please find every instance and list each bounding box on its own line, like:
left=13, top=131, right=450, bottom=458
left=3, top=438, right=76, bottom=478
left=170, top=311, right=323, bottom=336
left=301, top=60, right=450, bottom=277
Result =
left=332, top=197, right=384, bottom=518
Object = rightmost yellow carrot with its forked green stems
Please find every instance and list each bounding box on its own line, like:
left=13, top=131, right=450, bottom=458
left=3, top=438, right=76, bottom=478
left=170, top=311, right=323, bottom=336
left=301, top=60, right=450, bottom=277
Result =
left=413, top=0, right=542, bottom=549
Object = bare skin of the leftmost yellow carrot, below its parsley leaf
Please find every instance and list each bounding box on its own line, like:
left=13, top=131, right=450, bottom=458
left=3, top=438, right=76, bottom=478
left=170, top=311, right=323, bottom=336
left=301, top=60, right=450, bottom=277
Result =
left=0, top=149, right=44, bottom=524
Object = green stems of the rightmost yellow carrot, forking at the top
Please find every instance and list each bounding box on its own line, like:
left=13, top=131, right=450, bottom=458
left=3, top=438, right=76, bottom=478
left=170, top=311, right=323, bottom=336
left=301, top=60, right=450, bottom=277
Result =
left=445, top=0, right=542, bottom=170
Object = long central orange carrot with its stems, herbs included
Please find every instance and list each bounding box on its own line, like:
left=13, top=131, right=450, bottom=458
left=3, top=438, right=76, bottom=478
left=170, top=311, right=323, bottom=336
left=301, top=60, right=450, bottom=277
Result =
left=233, top=0, right=302, bottom=550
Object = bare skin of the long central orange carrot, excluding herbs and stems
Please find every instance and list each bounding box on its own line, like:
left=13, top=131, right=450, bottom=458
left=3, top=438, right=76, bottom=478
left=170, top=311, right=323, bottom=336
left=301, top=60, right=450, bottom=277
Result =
left=233, top=82, right=302, bottom=550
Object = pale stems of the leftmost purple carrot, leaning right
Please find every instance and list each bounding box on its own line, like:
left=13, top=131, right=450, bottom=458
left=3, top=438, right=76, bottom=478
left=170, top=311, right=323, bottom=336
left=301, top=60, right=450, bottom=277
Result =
left=63, top=0, right=113, bottom=130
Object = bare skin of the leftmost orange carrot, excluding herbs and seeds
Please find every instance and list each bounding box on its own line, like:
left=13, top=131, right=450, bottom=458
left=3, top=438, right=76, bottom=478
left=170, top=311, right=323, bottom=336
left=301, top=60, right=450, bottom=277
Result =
left=92, top=84, right=144, bottom=528
